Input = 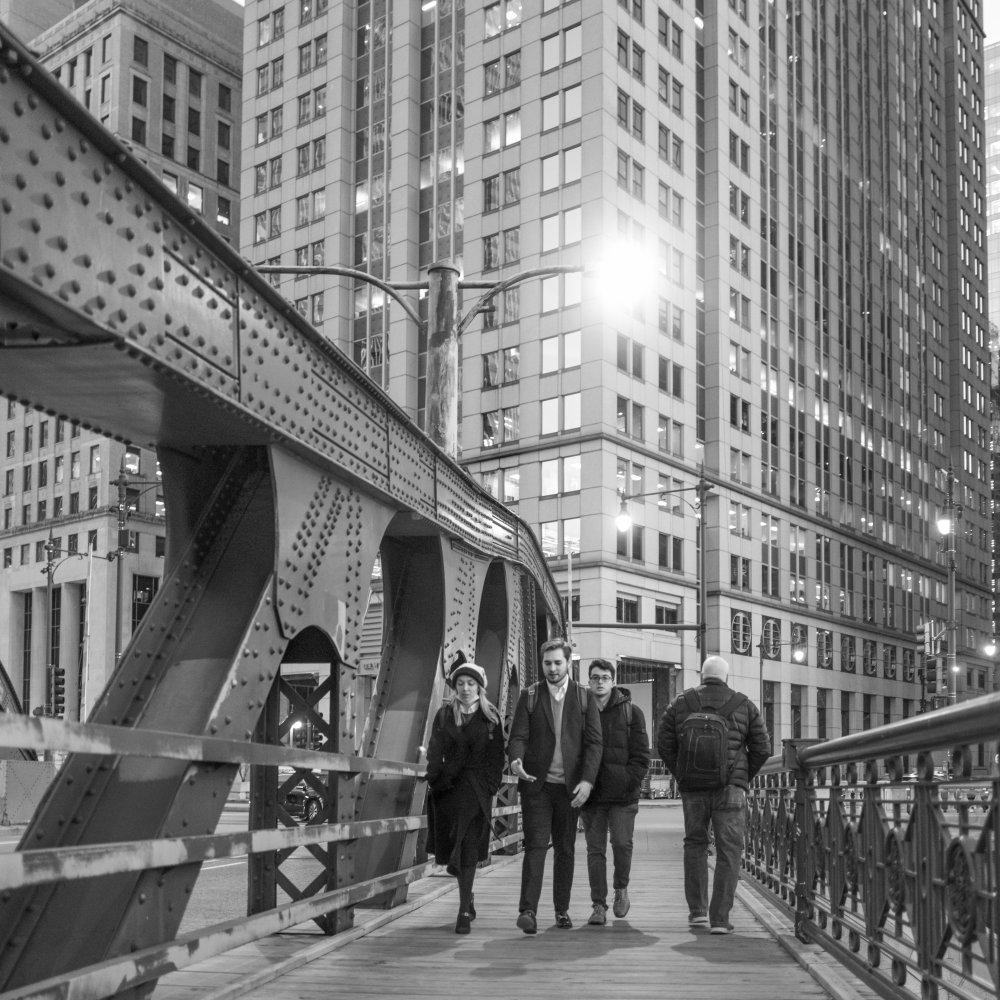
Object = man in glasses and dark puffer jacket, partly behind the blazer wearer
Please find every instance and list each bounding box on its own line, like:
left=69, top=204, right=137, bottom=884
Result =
left=580, top=660, right=649, bottom=927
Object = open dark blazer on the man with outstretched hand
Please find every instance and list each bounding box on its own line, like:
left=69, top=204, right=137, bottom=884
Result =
left=507, top=679, right=601, bottom=795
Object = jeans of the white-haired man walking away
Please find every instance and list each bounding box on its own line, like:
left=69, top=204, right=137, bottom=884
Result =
left=681, top=785, right=747, bottom=927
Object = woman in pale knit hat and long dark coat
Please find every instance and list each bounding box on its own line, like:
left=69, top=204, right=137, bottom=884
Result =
left=427, top=654, right=504, bottom=934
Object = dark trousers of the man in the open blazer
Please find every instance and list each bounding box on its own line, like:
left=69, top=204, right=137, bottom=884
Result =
left=518, top=781, right=577, bottom=913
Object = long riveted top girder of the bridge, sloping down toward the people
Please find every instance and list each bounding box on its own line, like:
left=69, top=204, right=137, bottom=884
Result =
left=0, top=24, right=559, bottom=613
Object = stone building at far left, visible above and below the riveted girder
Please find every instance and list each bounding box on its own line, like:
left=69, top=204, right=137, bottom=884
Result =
left=0, top=0, right=243, bottom=719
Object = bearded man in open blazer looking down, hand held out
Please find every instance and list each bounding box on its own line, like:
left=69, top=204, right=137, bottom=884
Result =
left=507, top=639, right=602, bottom=934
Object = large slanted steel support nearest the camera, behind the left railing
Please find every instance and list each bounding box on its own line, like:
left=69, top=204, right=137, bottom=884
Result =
left=0, top=449, right=280, bottom=988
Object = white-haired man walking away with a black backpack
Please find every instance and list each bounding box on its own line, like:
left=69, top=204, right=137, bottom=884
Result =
left=656, top=656, right=771, bottom=934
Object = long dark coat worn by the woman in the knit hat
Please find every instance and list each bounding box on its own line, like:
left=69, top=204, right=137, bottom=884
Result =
left=427, top=705, right=504, bottom=869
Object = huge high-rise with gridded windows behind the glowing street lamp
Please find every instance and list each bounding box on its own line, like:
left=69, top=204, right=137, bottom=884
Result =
left=241, top=0, right=992, bottom=752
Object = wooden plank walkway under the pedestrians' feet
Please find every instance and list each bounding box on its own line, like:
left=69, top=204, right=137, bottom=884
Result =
left=154, top=802, right=875, bottom=1000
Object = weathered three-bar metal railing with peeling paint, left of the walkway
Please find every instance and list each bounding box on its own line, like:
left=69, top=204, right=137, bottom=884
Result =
left=0, top=713, right=521, bottom=1000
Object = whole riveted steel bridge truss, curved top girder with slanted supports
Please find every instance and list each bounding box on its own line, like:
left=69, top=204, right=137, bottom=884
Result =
left=0, top=25, right=561, bottom=989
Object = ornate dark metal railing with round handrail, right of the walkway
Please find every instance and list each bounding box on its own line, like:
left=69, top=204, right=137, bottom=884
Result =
left=744, top=694, right=1000, bottom=1000
